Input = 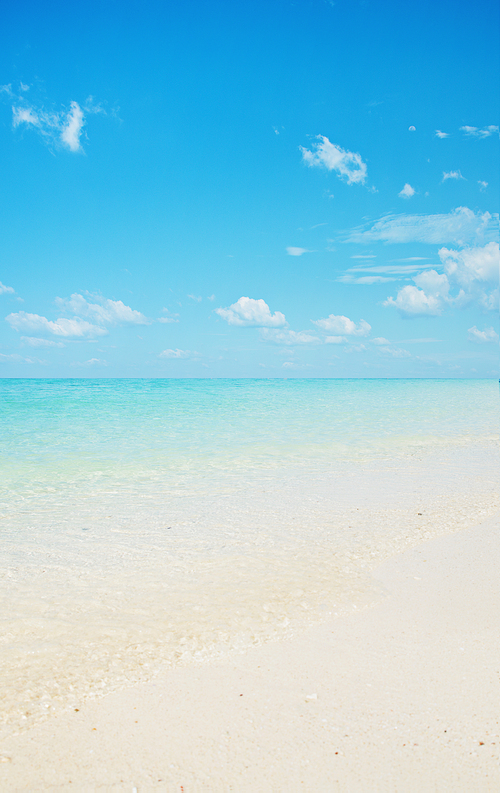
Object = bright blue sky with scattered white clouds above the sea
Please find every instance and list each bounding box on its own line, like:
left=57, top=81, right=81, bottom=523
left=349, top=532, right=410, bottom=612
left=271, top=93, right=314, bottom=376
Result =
left=0, top=0, right=499, bottom=378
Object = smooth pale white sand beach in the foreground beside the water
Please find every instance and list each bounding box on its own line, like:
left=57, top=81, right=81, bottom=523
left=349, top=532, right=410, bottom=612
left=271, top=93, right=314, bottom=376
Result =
left=0, top=516, right=500, bottom=793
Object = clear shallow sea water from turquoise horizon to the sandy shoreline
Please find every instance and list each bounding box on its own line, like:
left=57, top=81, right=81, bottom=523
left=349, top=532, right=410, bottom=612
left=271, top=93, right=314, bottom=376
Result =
left=0, top=379, right=498, bottom=729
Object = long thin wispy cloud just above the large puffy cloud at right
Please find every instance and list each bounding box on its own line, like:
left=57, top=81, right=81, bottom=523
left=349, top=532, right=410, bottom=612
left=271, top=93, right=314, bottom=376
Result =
left=343, top=207, right=498, bottom=245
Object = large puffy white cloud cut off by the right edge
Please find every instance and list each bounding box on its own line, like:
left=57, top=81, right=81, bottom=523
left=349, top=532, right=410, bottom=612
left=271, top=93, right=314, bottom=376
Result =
left=383, top=242, right=500, bottom=317
